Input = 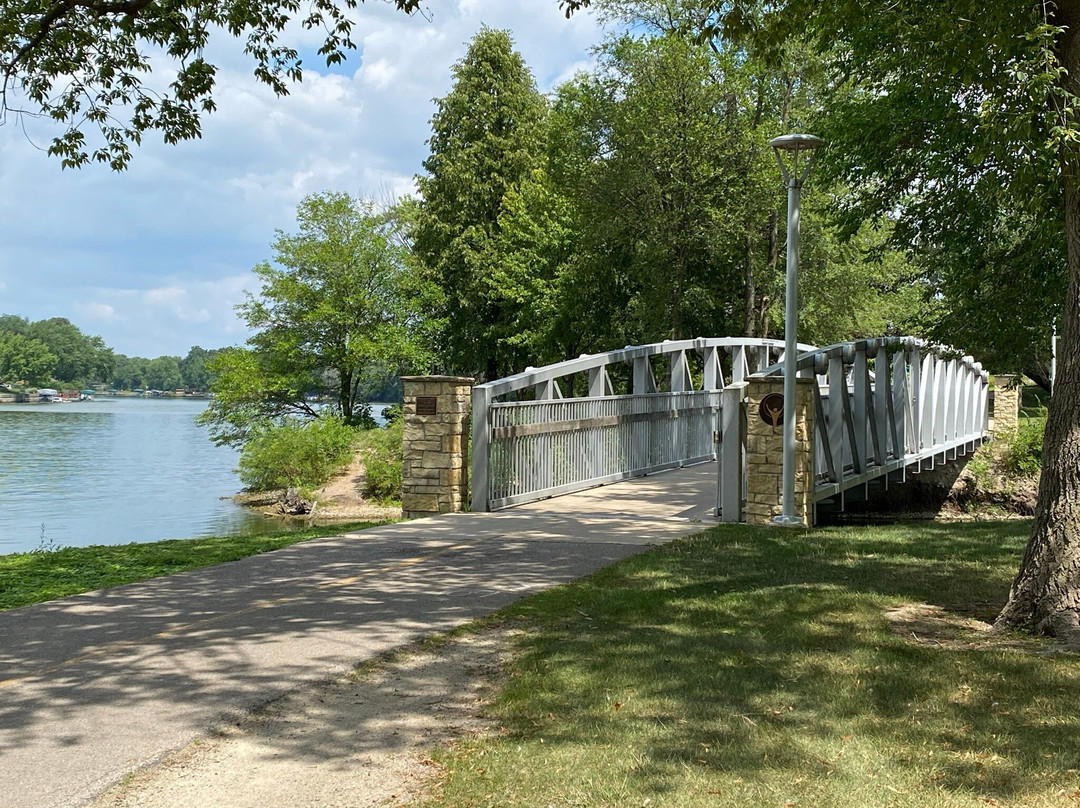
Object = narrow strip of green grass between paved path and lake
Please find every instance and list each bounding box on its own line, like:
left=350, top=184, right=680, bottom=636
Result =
left=0, top=522, right=386, bottom=610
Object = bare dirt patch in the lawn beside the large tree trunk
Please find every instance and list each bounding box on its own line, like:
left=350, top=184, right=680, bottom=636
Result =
left=885, top=603, right=1062, bottom=654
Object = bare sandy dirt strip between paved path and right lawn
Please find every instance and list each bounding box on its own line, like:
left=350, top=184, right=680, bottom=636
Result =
left=92, top=630, right=510, bottom=808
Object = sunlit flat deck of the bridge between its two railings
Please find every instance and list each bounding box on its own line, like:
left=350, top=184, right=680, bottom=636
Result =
left=503, top=462, right=717, bottom=523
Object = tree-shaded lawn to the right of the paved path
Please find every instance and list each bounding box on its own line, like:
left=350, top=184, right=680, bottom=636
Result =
left=425, top=522, right=1080, bottom=808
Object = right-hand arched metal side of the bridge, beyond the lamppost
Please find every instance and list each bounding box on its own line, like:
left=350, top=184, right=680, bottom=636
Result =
left=759, top=337, right=989, bottom=502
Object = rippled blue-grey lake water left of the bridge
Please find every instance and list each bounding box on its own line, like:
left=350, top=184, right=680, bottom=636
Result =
left=0, top=396, right=383, bottom=554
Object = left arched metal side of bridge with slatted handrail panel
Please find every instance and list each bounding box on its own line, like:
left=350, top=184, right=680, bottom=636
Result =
left=471, top=337, right=813, bottom=511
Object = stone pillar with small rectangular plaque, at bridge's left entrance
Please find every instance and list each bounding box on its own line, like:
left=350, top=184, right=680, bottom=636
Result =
left=402, top=376, right=473, bottom=519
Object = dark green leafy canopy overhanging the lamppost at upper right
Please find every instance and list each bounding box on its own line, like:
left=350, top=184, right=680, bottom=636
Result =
left=564, top=0, right=1067, bottom=378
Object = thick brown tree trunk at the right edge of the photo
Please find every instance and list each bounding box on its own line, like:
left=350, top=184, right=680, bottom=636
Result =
left=997, top=0, right=1080, bottom=647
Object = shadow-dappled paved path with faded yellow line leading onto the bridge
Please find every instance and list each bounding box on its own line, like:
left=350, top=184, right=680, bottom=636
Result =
left=0, top=463, right=716, bottom=808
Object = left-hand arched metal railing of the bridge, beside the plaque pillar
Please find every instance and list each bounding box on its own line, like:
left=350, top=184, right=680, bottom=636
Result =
left=471, top=337, right=812, bottom=511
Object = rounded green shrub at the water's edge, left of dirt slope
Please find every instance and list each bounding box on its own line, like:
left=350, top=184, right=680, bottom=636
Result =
left=238, top=415, right=356, bottom=490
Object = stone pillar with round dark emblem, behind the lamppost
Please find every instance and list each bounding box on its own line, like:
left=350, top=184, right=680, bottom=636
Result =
left=746, top=376, right=818, bottom=527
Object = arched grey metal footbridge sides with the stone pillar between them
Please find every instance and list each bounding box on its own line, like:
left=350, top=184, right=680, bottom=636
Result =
left=471, top=337, right=988, bottom=522
